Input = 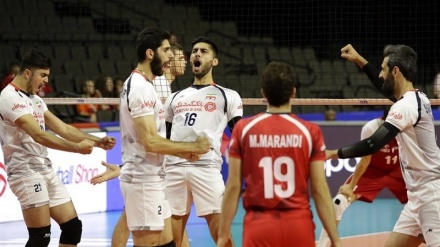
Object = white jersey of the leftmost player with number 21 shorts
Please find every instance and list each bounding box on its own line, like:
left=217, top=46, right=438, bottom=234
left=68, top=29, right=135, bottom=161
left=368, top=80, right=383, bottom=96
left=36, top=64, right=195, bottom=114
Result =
left=0, top=84, right=52, bottom=180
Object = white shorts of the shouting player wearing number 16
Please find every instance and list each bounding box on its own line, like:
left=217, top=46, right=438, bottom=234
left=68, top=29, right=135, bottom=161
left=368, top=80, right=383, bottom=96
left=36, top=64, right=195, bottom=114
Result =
left=165, top=166, right=225, bottom=216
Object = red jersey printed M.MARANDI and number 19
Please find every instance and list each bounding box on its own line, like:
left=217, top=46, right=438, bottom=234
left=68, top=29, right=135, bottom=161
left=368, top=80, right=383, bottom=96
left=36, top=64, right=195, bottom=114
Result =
left=229, top=113, right=325, bottom=210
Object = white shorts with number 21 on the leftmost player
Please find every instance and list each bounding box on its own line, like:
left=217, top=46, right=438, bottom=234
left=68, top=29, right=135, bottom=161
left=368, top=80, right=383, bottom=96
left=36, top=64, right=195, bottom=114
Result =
left=9, top=170, right=71, bottom=210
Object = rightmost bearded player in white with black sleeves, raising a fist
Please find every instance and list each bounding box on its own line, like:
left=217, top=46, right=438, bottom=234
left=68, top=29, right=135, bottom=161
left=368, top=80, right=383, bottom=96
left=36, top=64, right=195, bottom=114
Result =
left=327, top=45, right=440, bottom=247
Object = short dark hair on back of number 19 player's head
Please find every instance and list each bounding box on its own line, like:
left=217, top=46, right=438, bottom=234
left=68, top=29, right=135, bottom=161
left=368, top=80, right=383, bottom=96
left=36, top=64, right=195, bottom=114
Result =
left=261, top=61, right=296, bottom=106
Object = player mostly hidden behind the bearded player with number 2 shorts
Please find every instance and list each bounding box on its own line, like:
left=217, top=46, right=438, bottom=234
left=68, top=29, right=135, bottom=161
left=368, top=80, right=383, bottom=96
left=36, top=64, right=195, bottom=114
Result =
left=91, top=43, right=189, bottom=247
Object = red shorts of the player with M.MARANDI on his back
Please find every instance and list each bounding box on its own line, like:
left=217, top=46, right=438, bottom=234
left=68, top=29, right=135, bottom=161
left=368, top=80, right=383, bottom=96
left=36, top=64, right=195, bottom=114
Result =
left=243, top=210, right=315, bottom=247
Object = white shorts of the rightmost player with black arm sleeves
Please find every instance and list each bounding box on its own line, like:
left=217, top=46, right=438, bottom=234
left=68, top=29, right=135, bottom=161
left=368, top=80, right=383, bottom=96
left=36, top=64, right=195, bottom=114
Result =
left=393, top=182, right=440, bottom=247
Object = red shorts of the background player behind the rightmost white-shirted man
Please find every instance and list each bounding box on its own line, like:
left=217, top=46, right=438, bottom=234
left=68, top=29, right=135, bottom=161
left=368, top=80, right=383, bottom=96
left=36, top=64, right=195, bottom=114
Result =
left=346, top=167, right=408, bottom=204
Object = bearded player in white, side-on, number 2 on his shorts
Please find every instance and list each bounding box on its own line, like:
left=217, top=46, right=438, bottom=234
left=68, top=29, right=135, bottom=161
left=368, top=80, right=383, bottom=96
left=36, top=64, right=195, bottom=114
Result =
left=114, top=28, right=211, bottom=247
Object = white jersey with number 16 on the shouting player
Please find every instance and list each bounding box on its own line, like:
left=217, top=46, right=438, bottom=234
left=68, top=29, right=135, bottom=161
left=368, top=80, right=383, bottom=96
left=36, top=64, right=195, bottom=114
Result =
left=165, top=84, right=243, bottom=168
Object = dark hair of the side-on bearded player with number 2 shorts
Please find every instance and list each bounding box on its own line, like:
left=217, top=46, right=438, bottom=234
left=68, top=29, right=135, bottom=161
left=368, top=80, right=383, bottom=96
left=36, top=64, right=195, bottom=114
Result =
left=136, top=27, right=170, bottom=62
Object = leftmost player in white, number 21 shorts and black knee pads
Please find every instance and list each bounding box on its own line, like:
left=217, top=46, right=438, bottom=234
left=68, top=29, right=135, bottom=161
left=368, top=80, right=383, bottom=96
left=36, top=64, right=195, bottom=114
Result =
left=0, top=49, right=115, bottom=247
